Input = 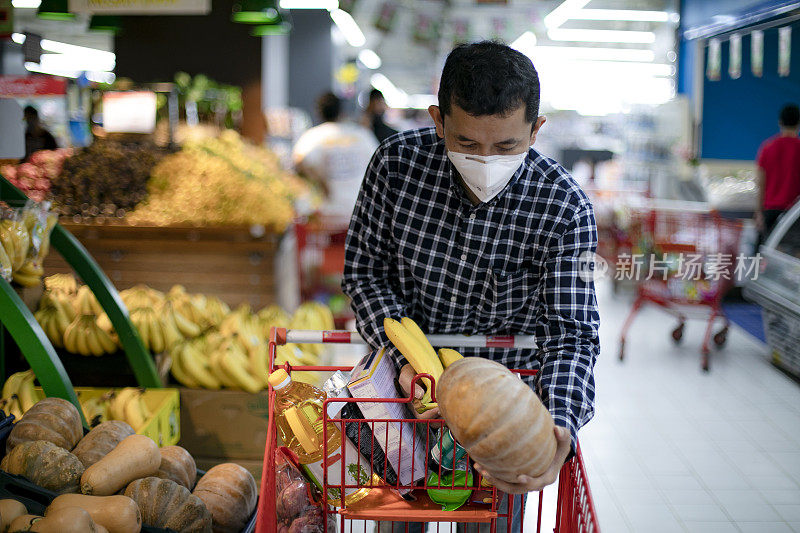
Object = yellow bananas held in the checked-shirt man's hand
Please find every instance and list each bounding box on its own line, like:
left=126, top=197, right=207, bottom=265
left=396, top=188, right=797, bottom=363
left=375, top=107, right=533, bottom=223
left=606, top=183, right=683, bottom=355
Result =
left=383, top=317, right=444, bottom=412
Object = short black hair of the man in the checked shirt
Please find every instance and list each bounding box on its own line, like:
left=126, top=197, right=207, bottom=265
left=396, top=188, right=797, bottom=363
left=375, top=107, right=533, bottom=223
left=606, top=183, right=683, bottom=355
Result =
left=439, top=41, right=539, bottom=123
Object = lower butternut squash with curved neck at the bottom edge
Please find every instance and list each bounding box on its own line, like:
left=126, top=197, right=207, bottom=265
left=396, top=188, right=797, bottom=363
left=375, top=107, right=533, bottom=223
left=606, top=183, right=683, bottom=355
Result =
left=45, top=494, right=142, bottom=533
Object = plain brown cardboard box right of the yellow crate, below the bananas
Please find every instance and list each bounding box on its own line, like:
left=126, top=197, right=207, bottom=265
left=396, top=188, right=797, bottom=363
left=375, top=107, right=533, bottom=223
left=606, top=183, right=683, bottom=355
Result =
left=179, top=388, right=269, bottom=460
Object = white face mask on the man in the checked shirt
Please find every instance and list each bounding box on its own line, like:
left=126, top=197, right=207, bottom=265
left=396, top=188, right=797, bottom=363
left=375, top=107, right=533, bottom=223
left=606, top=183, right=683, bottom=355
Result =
left=447, top=150, right=528, bottom=202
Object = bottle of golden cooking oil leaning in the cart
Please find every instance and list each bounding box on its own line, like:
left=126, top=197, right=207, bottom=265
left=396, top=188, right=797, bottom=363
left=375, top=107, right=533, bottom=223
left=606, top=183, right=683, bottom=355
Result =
left=269, top=369, right=382, bottom=506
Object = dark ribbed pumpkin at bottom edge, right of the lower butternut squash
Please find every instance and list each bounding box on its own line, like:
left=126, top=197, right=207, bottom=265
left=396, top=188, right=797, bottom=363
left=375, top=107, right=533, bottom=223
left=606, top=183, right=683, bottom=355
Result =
left=125, top=477, right=211, bottom=533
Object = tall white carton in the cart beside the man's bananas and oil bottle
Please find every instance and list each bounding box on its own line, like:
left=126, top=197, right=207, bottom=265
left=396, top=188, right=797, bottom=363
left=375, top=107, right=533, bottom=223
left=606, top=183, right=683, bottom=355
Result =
left=347, top=349, right=427, bottom=485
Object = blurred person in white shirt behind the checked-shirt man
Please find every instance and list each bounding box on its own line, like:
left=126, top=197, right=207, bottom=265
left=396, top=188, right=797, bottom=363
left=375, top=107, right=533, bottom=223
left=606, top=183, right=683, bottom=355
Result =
left=292, top=92, right=378, bottom=217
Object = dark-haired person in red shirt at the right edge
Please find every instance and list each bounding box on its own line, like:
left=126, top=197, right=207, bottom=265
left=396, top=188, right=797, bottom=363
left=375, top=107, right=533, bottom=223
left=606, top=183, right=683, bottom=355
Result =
left=755, top=104, right=800, bottom=247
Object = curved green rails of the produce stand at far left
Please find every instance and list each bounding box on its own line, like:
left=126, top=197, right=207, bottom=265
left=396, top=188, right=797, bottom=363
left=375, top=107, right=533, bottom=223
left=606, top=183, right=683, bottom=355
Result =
left=0, top=176, right=162, bottom=411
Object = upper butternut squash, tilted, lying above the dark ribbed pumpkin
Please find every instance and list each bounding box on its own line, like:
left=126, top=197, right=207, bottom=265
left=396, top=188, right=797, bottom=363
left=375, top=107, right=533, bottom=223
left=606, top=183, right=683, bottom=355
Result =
left=81, top=435, right=161, bottom=496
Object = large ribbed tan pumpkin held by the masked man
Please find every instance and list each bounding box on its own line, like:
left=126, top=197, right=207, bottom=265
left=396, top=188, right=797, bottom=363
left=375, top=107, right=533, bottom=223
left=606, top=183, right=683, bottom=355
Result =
left=436, top=357, right=556, bottom=483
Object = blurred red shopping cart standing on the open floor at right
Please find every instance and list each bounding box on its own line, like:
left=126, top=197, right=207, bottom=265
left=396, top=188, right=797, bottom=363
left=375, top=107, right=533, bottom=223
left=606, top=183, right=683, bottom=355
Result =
left=615, top=203, right=742, bottom=371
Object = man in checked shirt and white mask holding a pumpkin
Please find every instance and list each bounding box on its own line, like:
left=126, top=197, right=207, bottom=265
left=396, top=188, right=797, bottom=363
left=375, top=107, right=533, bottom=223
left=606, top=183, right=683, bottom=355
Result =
left=342, top=42, right=599, bottom=531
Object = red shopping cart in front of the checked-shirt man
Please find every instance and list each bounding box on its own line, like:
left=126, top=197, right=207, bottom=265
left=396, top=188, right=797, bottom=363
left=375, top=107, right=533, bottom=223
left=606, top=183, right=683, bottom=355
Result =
left=256, top=328, right=600, bottom=533
